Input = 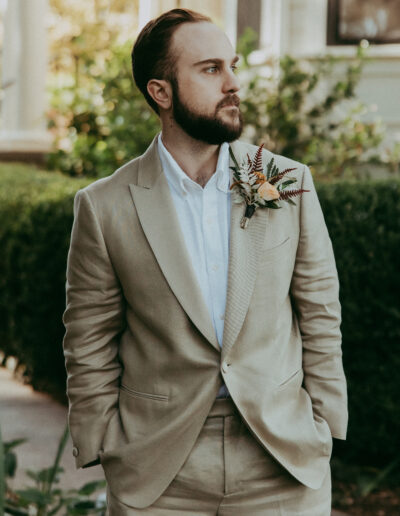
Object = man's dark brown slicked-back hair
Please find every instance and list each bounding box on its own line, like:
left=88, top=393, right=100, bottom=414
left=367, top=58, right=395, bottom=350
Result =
left=132, top=9, right=212, bottom=114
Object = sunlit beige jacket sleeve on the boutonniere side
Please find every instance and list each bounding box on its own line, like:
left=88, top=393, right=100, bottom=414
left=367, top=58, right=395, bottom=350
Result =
left=291, top=167, right=348, bottom=439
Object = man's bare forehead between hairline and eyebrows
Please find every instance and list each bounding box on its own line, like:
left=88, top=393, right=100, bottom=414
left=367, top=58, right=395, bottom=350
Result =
left=172, top=22, right=235, bottom=64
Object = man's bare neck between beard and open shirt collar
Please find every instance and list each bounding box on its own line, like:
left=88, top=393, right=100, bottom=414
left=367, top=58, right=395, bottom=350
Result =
left=161, top=127, right=220, bottom=188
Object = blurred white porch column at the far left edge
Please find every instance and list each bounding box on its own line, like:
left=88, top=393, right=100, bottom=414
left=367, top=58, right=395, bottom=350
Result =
left=0, top=0, right=51, bottom=160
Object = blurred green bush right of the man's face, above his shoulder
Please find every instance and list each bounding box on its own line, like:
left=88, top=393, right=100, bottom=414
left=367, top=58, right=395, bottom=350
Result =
left=241, top=30, right=400, bottom=179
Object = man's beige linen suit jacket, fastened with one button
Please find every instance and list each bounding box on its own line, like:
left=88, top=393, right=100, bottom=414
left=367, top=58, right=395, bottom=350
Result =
left=63, top=133, right=347, bottom=508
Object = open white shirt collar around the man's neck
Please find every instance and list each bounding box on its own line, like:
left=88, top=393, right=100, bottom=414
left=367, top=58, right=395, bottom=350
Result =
left=157, top=133, right=230, bottom=195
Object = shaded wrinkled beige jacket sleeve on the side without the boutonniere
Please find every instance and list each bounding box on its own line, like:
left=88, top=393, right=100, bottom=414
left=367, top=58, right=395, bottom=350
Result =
left=63, top=190, right=124, bottom=468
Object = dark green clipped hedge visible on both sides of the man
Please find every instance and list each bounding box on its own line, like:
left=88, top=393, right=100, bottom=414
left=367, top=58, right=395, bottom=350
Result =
left=0, top=166, right=400, bottom=466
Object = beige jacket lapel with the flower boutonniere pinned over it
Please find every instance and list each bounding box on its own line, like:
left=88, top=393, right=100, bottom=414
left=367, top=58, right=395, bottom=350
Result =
left=222, top=142, right=269, bottom=359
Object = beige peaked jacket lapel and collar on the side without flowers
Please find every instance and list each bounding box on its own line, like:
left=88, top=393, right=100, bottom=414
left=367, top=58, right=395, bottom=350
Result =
left=129, top=137, right=220, bottom=351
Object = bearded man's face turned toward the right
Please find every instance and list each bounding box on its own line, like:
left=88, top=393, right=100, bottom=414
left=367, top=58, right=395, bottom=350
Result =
left=167, top=22, right=243, bottom=145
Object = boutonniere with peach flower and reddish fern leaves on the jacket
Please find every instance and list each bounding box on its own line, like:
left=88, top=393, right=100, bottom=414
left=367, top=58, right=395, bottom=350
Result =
left=229, top=144, right=310, bottom=229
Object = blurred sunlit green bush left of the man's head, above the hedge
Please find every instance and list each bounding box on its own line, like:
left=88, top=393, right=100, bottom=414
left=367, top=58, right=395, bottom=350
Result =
left=47, top=40, right=159, bottom=177
